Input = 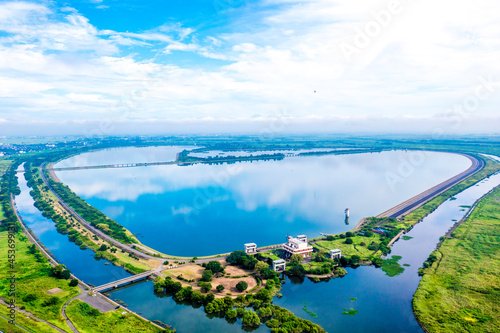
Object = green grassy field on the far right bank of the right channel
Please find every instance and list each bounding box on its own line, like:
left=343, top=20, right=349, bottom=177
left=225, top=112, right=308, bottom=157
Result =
left=413, top=183, right=500, bottom=332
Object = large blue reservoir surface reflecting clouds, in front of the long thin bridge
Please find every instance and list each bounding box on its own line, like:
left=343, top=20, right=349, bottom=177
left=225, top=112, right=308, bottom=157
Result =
left=57, top=150, right=470, bottom=255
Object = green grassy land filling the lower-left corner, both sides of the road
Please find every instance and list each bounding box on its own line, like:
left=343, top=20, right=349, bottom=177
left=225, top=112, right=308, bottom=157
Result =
left=0, top=162, right=170, bottom=333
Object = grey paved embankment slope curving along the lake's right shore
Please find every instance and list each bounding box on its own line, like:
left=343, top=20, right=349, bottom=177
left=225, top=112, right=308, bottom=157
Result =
left=376, top=154, right=485, bottom=218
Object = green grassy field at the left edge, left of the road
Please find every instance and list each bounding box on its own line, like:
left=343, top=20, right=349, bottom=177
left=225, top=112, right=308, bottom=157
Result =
left=0, top=231, right=80, bottom=332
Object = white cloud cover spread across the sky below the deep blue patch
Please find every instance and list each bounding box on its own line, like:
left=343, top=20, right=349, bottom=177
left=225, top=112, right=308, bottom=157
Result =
left=0, top=0, right=500, bottom=131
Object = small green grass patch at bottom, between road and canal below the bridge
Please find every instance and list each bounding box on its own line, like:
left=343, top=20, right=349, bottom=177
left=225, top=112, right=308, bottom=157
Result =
left=66, top=299, right=170, bottom=333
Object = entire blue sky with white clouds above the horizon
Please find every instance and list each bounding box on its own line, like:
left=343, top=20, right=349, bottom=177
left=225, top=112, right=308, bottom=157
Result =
left=0, top=0, right=500, bottom=136
